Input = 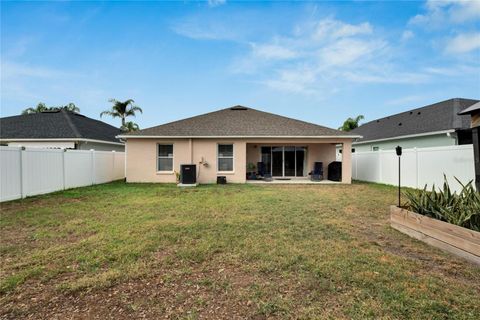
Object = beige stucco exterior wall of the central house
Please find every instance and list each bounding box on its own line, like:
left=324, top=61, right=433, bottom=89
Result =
left=126, top=138, right=351, bottom=183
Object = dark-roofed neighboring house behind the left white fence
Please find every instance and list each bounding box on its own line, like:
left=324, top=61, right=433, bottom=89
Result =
left=0, top=110, right=125, bottom=151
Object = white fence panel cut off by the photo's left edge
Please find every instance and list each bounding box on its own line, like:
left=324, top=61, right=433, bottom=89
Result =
left=0, top=146, right=22, bottom=201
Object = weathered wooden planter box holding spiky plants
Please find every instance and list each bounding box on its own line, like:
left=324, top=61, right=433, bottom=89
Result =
left=390, top=206, right=480, bottom=265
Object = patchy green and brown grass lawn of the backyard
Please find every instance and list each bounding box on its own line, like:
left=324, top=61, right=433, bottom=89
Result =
left=0, top=182, right=480, bottom=319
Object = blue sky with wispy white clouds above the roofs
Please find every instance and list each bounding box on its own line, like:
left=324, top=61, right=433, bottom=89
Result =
left=0, top=1, right=480, bottom=128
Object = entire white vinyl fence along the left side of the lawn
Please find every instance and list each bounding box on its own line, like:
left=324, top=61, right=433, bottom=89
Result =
left=0, top=146, right=125, bottom=202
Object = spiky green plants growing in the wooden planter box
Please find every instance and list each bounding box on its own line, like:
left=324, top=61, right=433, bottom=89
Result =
left=405, top=176, right=480, bottom=231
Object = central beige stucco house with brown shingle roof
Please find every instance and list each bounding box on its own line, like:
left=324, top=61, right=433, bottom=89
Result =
left=119, top=106, right=360, bottom=183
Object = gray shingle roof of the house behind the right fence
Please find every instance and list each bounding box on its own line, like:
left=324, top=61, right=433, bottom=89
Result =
left=350, top=98, right=478, bottom=142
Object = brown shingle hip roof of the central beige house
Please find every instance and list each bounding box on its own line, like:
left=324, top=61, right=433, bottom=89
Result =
left=125, top=106, right=352, bottom=137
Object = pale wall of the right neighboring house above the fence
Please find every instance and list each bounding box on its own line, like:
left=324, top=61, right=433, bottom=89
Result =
left=353, top=133, right=457, bottom=152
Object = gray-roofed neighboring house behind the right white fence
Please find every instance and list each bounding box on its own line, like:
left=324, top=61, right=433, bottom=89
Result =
left=344, top=98, right=478, bottom=152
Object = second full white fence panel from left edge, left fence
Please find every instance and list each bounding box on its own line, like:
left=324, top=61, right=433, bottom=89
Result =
left=22, top=148, right=64, bottom=196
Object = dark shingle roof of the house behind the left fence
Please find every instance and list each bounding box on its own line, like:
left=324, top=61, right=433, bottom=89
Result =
left=0, top=110, right=122, bottom=142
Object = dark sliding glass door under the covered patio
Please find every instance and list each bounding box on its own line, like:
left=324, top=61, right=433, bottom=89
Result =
left=261, top=146, right=307, bottom=177
